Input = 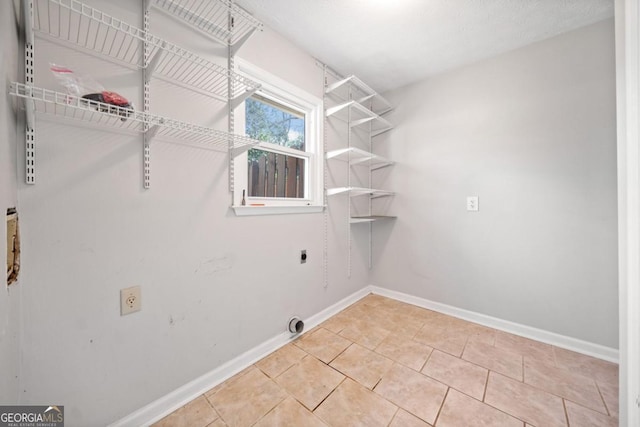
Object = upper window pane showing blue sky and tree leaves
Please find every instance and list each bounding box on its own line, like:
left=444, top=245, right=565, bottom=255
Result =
left=245, top=95, right=305, bottom=151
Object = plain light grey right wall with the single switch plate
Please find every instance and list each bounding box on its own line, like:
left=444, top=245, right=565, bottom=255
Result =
left=373, top=20, right=618, bottom=348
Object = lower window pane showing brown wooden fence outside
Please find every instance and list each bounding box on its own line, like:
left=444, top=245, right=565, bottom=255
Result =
left=248, top=148, right=306, bottom=199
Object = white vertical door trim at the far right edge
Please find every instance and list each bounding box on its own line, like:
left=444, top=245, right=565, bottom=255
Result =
left=615, top=0, right=640, bottom=427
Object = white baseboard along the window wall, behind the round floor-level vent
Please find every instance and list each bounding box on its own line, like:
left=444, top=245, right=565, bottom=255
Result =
left=109, top=286, right=371, bottom=427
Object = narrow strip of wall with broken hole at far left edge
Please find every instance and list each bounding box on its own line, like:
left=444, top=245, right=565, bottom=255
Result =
left=0, top=1, right=23, bottom=405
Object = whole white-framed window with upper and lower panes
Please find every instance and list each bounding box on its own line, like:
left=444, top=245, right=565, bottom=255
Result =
left=233, top=61, right=323, bottom=215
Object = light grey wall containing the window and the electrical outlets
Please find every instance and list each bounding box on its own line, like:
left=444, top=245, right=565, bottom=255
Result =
left=13, top=0, right=368, bottom=426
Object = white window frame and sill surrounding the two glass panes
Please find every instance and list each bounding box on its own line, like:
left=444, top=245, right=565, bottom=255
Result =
left=232, top=58, right=324, bottom=216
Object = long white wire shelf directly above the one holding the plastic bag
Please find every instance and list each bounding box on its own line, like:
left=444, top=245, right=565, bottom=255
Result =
left=33, top=0, right=260, bottom=104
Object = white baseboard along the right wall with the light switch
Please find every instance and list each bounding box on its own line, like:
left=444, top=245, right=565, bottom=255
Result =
left=368, top=286, right=619, bottom=363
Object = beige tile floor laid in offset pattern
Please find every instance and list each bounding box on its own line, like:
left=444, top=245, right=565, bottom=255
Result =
left=155, top=295, right=618, bottom=427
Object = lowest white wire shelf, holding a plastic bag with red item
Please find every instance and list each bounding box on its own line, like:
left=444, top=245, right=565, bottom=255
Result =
left=9, top=82, right=259, bottom=152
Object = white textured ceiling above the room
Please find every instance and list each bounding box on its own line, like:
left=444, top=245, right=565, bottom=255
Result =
left=236, top=0, right=614, bottom=92
